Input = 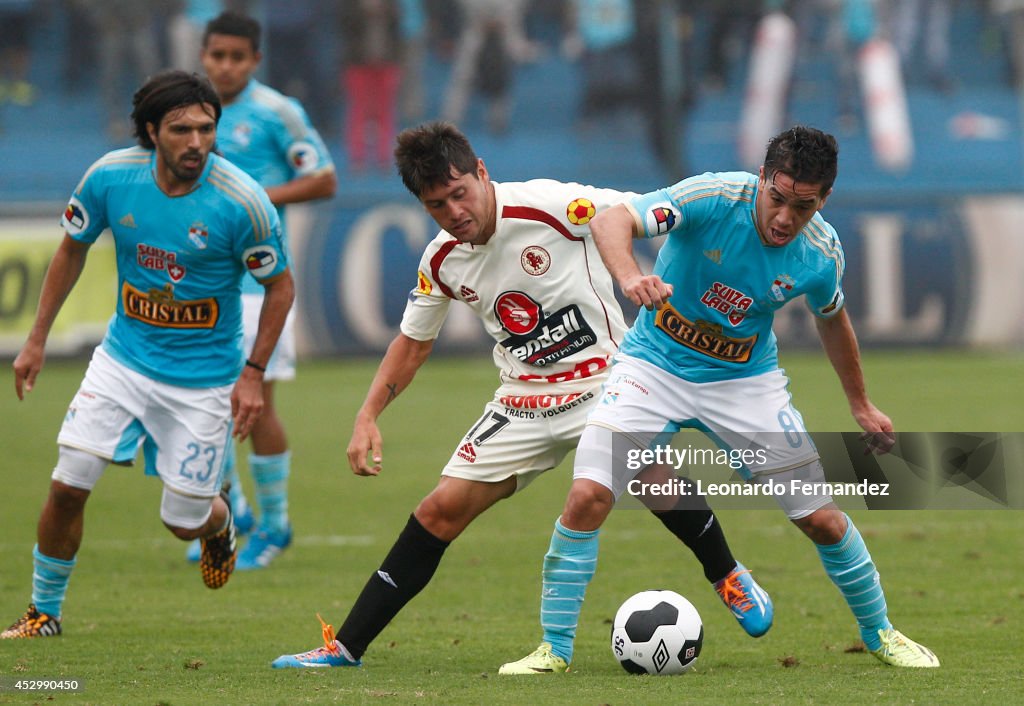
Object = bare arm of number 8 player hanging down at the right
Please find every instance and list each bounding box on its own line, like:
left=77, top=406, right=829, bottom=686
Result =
left=815, top=308, right=895, bottom=454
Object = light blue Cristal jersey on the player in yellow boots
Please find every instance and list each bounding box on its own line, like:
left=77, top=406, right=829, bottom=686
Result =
left=621, top=172, right=845, bottom=382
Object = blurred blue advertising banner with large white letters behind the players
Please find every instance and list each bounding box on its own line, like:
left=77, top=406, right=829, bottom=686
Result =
left=293, top=195, right=1024, bottom=355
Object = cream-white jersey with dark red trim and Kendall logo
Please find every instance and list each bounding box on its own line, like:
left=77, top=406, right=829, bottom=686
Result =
left=401, top=179, right=634, bottom=393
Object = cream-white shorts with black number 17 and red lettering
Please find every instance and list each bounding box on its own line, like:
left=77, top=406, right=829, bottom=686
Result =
left=441, top=385, right=600, bottom=491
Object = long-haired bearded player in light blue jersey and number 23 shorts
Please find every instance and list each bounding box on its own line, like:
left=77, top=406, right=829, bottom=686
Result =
left=0, top=71, right=294, bottom=638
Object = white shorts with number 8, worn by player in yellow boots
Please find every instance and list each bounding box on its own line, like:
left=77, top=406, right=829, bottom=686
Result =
left=573, top=355, right=818, bottom=496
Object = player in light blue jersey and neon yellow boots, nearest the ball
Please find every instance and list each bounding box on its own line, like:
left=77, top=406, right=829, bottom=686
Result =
left=502, top=127, right=939, bottom=674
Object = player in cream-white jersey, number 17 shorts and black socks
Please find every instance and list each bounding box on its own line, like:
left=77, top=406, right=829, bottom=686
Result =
left=272, top=123, right=772, bottom=668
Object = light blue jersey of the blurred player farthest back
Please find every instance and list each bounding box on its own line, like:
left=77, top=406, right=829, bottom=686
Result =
left=217, top=80, right=334, bottom=294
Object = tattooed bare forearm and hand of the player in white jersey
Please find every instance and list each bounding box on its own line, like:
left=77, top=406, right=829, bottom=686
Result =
left=347, top=333, right=434, bottom=475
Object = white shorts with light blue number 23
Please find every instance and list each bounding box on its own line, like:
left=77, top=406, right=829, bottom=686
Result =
left=57, top=345, right=233, bottom=498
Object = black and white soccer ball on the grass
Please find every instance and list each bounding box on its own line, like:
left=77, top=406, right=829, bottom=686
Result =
left=611, top=591, right=703, bottom=676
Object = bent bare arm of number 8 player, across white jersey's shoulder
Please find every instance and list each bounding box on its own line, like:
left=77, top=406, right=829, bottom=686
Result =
left=590, top=204, right=672, bottom=309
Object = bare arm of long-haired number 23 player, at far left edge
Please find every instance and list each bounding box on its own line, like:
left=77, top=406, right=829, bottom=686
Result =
left=13, top=235, right=89, bottom=400
